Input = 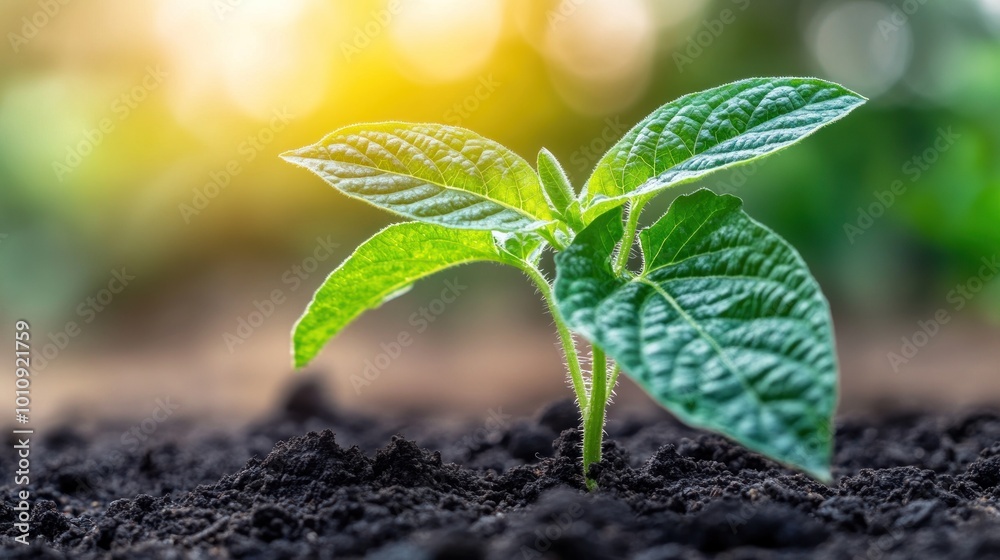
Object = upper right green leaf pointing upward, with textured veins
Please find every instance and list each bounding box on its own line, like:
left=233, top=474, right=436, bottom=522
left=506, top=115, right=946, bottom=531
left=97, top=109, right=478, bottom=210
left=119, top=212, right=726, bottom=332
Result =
left=582, top=78, right=865, bottom=223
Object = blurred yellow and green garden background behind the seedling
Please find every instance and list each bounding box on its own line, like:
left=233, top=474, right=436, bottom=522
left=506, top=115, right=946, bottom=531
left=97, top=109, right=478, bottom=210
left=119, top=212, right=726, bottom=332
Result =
left=0, top=0, right=1000, bottom=426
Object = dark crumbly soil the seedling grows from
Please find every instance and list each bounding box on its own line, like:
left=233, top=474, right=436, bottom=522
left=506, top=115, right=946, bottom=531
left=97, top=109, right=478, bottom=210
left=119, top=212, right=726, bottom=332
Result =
left=0, top=378, right=1000, bottom=560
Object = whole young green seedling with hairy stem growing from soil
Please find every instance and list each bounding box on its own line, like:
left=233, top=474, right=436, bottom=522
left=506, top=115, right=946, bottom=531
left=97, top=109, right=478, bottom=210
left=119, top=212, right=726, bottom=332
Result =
left=282, top=78, right=865, bottom=488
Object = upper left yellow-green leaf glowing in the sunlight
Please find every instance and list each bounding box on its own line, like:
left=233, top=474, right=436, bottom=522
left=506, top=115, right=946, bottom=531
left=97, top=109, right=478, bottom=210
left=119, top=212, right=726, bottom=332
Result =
left=282, top=122, right=553, bottom=231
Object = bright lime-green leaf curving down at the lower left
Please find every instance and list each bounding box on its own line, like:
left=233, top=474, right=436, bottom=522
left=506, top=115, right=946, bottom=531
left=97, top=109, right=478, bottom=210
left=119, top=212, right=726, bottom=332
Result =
left=292, top=222, right=510, bottom=368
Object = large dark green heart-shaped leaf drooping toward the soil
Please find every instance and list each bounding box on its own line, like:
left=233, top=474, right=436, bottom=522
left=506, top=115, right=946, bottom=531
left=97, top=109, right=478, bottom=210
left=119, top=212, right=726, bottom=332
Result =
left=555, top=190, right=837, bottom=480
